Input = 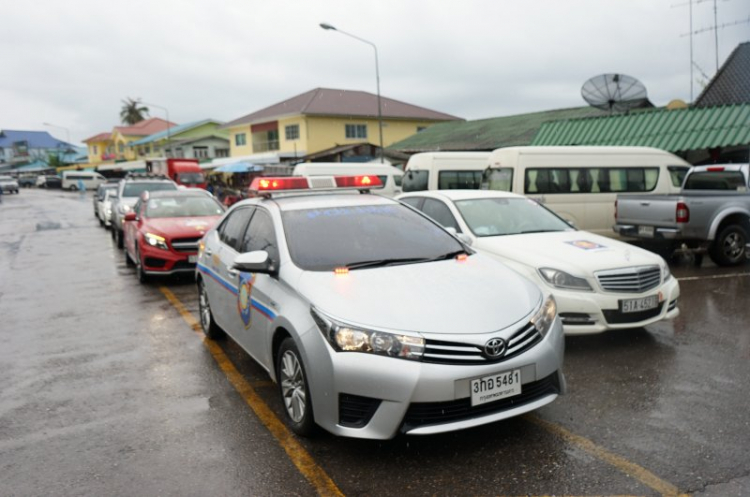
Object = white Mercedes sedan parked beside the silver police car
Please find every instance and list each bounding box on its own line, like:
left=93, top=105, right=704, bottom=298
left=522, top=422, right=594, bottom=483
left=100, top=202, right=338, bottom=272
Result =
left=398, top=190, right=680, bottom=335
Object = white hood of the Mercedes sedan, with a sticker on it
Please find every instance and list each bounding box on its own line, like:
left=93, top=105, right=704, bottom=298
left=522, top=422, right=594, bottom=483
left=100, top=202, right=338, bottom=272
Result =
left=472, top=231, right=661, bottom=276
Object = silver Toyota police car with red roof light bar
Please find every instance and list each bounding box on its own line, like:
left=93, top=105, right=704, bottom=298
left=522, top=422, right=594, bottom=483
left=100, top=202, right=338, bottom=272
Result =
left=196, top=176, right=565, bottom=439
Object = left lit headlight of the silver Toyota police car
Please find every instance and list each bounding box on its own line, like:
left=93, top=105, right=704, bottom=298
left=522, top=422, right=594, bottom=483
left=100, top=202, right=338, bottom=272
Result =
left=310, top=307, right=424, bottom=361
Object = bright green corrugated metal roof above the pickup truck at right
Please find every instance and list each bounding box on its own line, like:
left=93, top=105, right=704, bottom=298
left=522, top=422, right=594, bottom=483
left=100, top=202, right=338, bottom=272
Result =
left=531, top=104, right=750, bottom=152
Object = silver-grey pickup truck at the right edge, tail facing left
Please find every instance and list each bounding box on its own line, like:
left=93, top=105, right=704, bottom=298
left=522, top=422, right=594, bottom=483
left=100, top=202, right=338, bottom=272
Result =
left=614, top=164, right=750, bottom=266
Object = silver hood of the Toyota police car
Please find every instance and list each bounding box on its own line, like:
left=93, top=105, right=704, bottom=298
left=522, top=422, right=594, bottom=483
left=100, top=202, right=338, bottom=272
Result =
left=297, top=254, right=542, bottom=334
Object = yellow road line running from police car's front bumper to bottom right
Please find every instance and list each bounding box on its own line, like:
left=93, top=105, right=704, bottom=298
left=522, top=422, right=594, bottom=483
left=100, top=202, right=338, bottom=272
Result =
left=524, top=415, right=688, bottom=497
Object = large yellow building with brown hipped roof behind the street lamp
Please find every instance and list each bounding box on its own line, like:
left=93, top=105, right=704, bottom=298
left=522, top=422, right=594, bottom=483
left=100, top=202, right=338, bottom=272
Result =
left=223, top=88, right=462, bottom=157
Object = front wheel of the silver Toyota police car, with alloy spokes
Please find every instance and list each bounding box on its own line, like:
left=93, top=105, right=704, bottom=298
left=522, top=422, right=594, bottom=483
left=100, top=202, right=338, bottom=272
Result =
left=276, top=337, right=315, bottom=437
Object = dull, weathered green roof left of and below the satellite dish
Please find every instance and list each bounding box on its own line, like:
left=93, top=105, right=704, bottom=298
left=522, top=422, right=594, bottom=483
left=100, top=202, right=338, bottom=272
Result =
left=388, top=107, right=604, bottom=152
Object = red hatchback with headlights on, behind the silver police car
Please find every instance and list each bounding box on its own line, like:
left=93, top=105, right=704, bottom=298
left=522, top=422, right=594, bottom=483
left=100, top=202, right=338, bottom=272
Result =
left=123, top=189, right=224, bottom=283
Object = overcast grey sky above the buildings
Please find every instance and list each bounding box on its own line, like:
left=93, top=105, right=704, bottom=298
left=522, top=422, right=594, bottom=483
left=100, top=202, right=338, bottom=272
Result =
left=0, top=0, right=750, bottom=142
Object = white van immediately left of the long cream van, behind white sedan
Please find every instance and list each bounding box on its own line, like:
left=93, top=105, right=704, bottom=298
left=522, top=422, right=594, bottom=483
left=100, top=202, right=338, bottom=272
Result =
left=404, top=152, right=490, bottom=192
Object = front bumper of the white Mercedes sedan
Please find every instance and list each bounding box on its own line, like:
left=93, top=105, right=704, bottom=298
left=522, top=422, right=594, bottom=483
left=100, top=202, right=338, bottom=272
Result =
left=553, top=276, right=680, bottom=335
